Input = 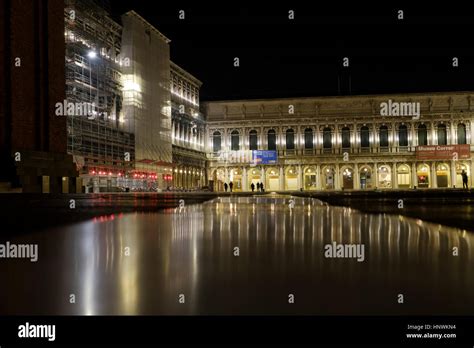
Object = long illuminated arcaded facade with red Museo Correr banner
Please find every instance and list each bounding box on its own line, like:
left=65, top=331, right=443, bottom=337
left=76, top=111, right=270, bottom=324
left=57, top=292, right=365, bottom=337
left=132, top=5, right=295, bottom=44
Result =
left=204, top=92, right=474, bottom=191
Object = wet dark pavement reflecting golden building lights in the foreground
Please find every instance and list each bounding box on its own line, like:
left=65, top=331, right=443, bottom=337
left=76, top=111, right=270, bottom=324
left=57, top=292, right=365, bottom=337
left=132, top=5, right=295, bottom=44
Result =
left=0, top=195, right=474, bottom=315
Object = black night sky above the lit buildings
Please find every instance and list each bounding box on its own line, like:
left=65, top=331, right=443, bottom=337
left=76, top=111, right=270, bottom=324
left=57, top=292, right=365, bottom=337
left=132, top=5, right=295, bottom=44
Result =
left=111, top=0, right=474, bottom=101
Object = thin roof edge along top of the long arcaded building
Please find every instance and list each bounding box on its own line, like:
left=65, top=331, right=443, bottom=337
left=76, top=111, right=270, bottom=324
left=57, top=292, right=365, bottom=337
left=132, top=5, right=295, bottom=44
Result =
left=201, top=91, right=474, bottom=105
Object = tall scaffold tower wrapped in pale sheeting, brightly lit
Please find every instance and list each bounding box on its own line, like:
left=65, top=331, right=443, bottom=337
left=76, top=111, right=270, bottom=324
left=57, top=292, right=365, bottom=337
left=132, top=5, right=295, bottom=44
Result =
left=121, top=11, right=172, bottom=188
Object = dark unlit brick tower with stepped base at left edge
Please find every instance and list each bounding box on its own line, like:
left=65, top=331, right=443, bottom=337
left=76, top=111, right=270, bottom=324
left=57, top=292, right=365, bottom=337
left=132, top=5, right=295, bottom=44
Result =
left=0, top=0, right=77, bottom=192
